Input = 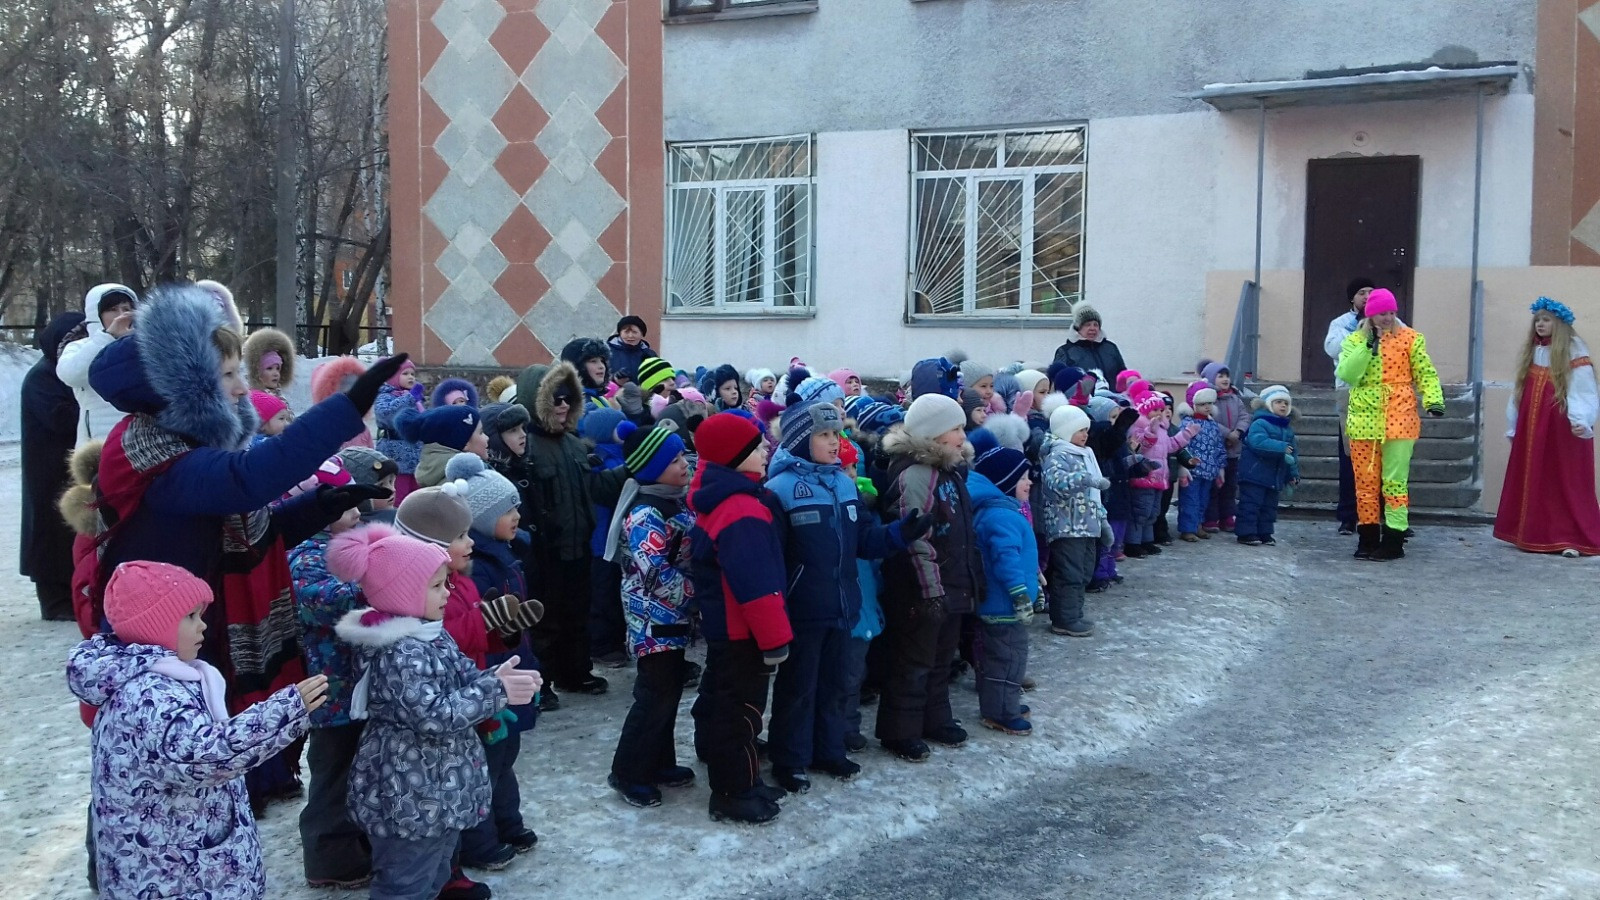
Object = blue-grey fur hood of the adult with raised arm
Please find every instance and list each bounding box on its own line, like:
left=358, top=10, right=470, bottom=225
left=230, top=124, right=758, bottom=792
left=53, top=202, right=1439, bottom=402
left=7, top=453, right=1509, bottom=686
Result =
left=133, top=285, right=257, bottom=450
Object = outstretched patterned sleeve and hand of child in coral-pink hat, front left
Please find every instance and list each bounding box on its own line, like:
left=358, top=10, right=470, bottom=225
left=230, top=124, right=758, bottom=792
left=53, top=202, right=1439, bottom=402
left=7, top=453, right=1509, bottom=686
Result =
left=149, top=676, right=312, bottom=788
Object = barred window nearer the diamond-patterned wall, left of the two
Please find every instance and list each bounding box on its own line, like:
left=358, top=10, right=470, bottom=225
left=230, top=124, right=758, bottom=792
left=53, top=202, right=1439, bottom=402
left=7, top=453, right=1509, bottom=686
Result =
left=667, top=136, right=816, bottom=312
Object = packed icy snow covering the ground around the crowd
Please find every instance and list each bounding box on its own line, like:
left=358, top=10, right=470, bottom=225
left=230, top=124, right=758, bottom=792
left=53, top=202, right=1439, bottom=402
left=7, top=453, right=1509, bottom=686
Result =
left=0, top=445, right=1600, bottom=900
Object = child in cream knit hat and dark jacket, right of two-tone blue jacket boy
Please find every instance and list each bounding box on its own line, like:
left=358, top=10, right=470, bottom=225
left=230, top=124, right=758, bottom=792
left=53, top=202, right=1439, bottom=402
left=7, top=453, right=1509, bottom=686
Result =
left=877, top=392, right=982, bottom=762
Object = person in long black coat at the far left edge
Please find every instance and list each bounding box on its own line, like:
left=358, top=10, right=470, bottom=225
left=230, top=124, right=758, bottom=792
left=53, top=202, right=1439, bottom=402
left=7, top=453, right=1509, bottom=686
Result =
left=21, top=312, right=83, bottom=621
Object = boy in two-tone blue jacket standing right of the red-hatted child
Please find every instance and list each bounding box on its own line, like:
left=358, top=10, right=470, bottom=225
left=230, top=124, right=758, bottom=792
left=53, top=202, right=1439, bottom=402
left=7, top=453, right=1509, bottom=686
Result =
left=766, top=400, right=931, bottom=793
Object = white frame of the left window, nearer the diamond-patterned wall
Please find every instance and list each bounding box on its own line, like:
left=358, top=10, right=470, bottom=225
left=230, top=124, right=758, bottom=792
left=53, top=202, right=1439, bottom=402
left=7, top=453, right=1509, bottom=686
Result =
left=662, top=135, right=816, bottom=317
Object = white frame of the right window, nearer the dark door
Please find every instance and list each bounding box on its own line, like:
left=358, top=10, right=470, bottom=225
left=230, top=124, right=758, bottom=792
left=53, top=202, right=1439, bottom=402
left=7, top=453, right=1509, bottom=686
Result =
left=906, top=122, right=1090, bottom=325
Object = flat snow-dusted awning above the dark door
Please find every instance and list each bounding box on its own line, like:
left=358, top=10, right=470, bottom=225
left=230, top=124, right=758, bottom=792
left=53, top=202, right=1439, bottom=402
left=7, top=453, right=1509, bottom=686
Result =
left=1189, top=62, right=1522, bottom=112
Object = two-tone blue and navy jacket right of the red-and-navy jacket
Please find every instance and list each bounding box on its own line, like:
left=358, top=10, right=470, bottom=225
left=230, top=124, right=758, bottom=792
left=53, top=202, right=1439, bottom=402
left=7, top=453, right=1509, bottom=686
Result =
left=766, top=450, right=906, bottom=631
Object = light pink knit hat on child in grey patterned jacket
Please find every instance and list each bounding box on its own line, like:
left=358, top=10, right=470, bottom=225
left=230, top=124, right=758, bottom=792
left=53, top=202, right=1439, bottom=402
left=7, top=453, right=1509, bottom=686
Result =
left=328, top=524, right=450, bottom=618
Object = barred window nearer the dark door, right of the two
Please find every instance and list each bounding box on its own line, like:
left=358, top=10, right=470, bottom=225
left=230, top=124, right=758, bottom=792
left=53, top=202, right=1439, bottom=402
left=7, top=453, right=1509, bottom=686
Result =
left=910, top=125, right=1086, bottom=317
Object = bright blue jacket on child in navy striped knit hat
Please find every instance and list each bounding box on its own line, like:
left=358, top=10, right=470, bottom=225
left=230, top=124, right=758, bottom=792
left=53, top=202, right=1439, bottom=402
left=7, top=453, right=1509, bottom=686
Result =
left=966, top=472, right=1038, bottom=623
